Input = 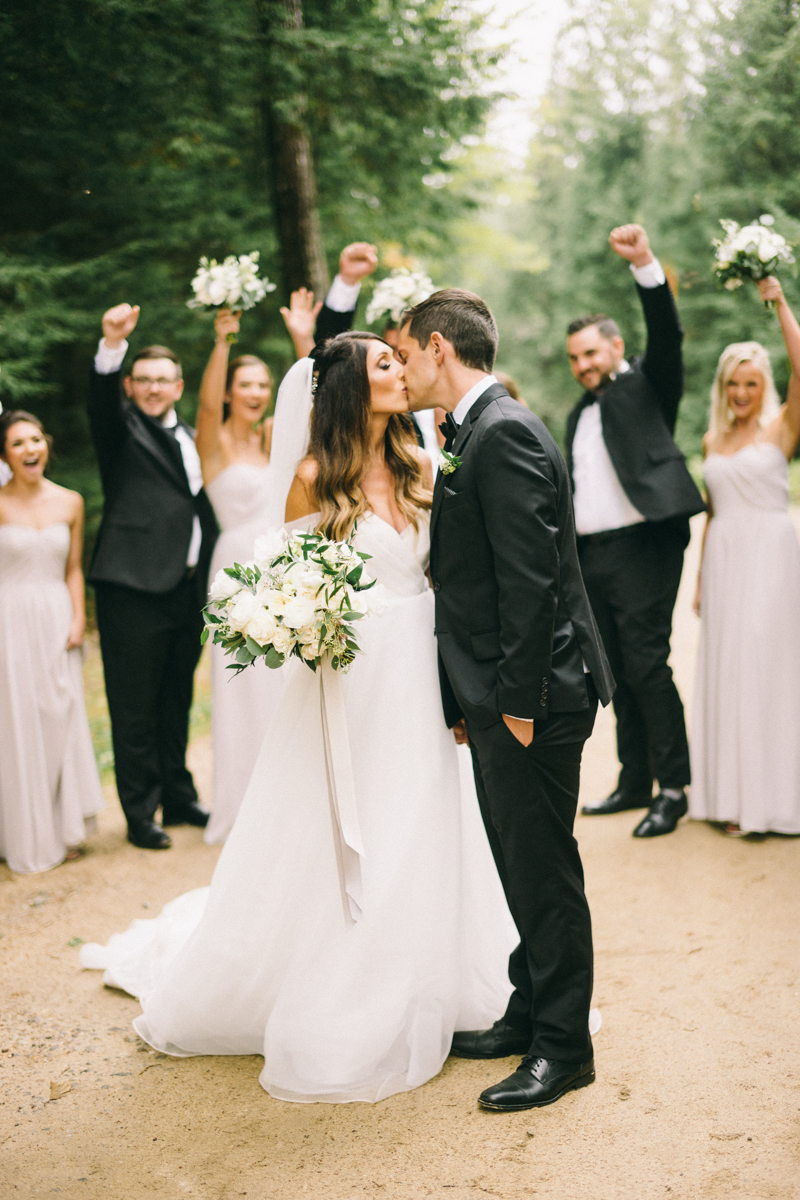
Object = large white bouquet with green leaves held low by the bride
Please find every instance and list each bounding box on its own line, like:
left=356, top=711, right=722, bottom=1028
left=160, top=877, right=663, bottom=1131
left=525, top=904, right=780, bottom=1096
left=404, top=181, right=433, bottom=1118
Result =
left=203, top=529, right=375, bottom=673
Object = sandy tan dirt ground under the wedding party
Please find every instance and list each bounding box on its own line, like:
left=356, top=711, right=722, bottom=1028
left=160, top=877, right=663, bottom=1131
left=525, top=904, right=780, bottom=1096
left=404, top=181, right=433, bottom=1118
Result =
left=0, top=516, right=800, bottom=1200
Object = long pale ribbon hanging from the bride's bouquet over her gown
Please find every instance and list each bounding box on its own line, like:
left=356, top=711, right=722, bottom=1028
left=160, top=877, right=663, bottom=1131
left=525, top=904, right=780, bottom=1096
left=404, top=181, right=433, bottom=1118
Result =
left=318, top=660, right=363, bottom=925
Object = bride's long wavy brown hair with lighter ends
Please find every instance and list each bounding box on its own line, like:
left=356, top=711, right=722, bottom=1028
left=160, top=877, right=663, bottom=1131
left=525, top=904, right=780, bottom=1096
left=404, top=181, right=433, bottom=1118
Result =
left=308, top=332, right=431, bottom=541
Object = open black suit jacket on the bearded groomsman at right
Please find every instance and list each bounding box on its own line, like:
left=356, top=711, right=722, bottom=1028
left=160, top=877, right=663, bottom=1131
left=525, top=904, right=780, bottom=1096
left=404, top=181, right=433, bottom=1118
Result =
left=566, top=283, right=705, bottom=521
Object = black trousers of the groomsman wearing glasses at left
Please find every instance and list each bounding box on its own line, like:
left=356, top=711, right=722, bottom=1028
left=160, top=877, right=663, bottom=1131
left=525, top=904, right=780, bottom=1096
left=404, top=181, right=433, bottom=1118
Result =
left=95, top=578, right=203, bottom=823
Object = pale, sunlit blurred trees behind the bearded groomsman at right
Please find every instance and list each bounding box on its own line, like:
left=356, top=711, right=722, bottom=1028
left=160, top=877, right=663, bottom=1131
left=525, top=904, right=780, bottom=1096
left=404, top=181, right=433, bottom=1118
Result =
left=462, top=0, right=800, bottom=454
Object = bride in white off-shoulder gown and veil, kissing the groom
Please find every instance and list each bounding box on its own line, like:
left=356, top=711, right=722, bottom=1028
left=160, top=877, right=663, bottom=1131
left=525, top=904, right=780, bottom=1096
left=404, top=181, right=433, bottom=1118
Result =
left=82, top=334, right=517, bottom=1102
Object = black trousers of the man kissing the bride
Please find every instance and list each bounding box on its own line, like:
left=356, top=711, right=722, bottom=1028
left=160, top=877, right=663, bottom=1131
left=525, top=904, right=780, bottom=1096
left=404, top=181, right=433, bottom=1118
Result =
left=467, top=678, right=597, bottom=1062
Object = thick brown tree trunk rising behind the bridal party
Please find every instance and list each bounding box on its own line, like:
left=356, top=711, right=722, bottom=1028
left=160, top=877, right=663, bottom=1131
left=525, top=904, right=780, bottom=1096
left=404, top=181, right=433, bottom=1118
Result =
left=257, top=0, right=329, bottom=299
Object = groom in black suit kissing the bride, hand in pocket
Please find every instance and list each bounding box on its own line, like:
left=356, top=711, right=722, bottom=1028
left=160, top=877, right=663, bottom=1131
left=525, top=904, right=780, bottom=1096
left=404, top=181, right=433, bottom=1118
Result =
left=398, top=288, right=614, bottom=1111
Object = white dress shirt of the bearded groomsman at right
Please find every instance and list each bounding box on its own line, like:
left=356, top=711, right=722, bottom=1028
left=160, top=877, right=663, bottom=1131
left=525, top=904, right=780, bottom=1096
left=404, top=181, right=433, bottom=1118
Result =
left=572, top=258, right=666, bottom=535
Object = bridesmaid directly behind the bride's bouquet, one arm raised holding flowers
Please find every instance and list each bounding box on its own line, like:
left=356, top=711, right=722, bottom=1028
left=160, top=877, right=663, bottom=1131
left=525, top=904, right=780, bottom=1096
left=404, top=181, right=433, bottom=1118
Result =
left=196, top=308, right=283, bottom=844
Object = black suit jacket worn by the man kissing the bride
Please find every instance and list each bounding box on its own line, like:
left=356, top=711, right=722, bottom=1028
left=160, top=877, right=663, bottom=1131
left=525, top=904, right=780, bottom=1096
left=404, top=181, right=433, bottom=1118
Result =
left=431, top=384, right=614, bottom=727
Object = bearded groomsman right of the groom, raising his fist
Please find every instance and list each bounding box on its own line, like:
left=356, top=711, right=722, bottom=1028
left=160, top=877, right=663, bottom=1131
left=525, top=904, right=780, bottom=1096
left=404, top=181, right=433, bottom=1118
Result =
left=566, top=224, right=705, bottom=838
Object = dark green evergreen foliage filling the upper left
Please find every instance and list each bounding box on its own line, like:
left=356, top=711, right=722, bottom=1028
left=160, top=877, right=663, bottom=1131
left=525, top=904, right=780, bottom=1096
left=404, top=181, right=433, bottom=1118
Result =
left=0, top=0, right=492, bottom=479
